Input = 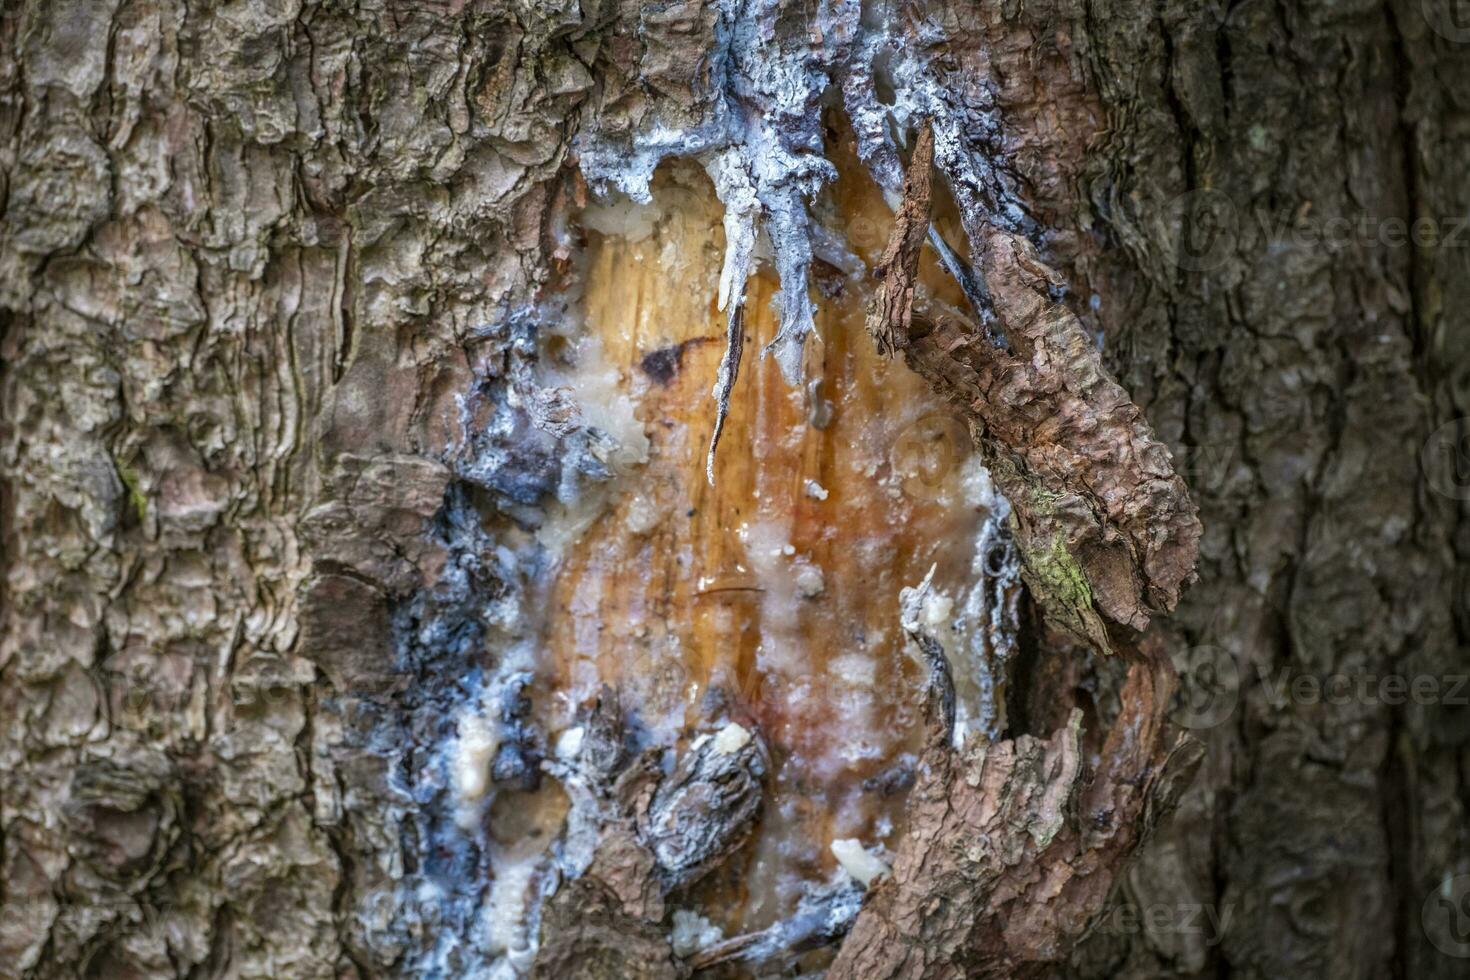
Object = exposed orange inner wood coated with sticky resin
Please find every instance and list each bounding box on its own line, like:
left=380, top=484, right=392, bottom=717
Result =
left=547, top=141, right=978, bottom=929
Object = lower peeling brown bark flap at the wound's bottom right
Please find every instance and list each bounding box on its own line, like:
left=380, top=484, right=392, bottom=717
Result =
left=828, top=631, right=1202, bottom=980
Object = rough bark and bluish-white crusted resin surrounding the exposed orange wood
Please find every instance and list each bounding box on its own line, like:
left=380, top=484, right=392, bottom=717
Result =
left=0, top=0, right=1470, bottom=980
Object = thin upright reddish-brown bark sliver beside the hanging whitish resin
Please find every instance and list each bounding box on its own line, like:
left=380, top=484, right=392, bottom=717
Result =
left=867, top=122, right=933, bottom=356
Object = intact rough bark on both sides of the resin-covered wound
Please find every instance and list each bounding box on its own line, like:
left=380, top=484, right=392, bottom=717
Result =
left=0, top=0, right=1470, bottom=980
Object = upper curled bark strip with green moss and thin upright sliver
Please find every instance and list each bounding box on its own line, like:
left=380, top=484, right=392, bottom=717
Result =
left=867, top=126, right=1200, bottom=649
